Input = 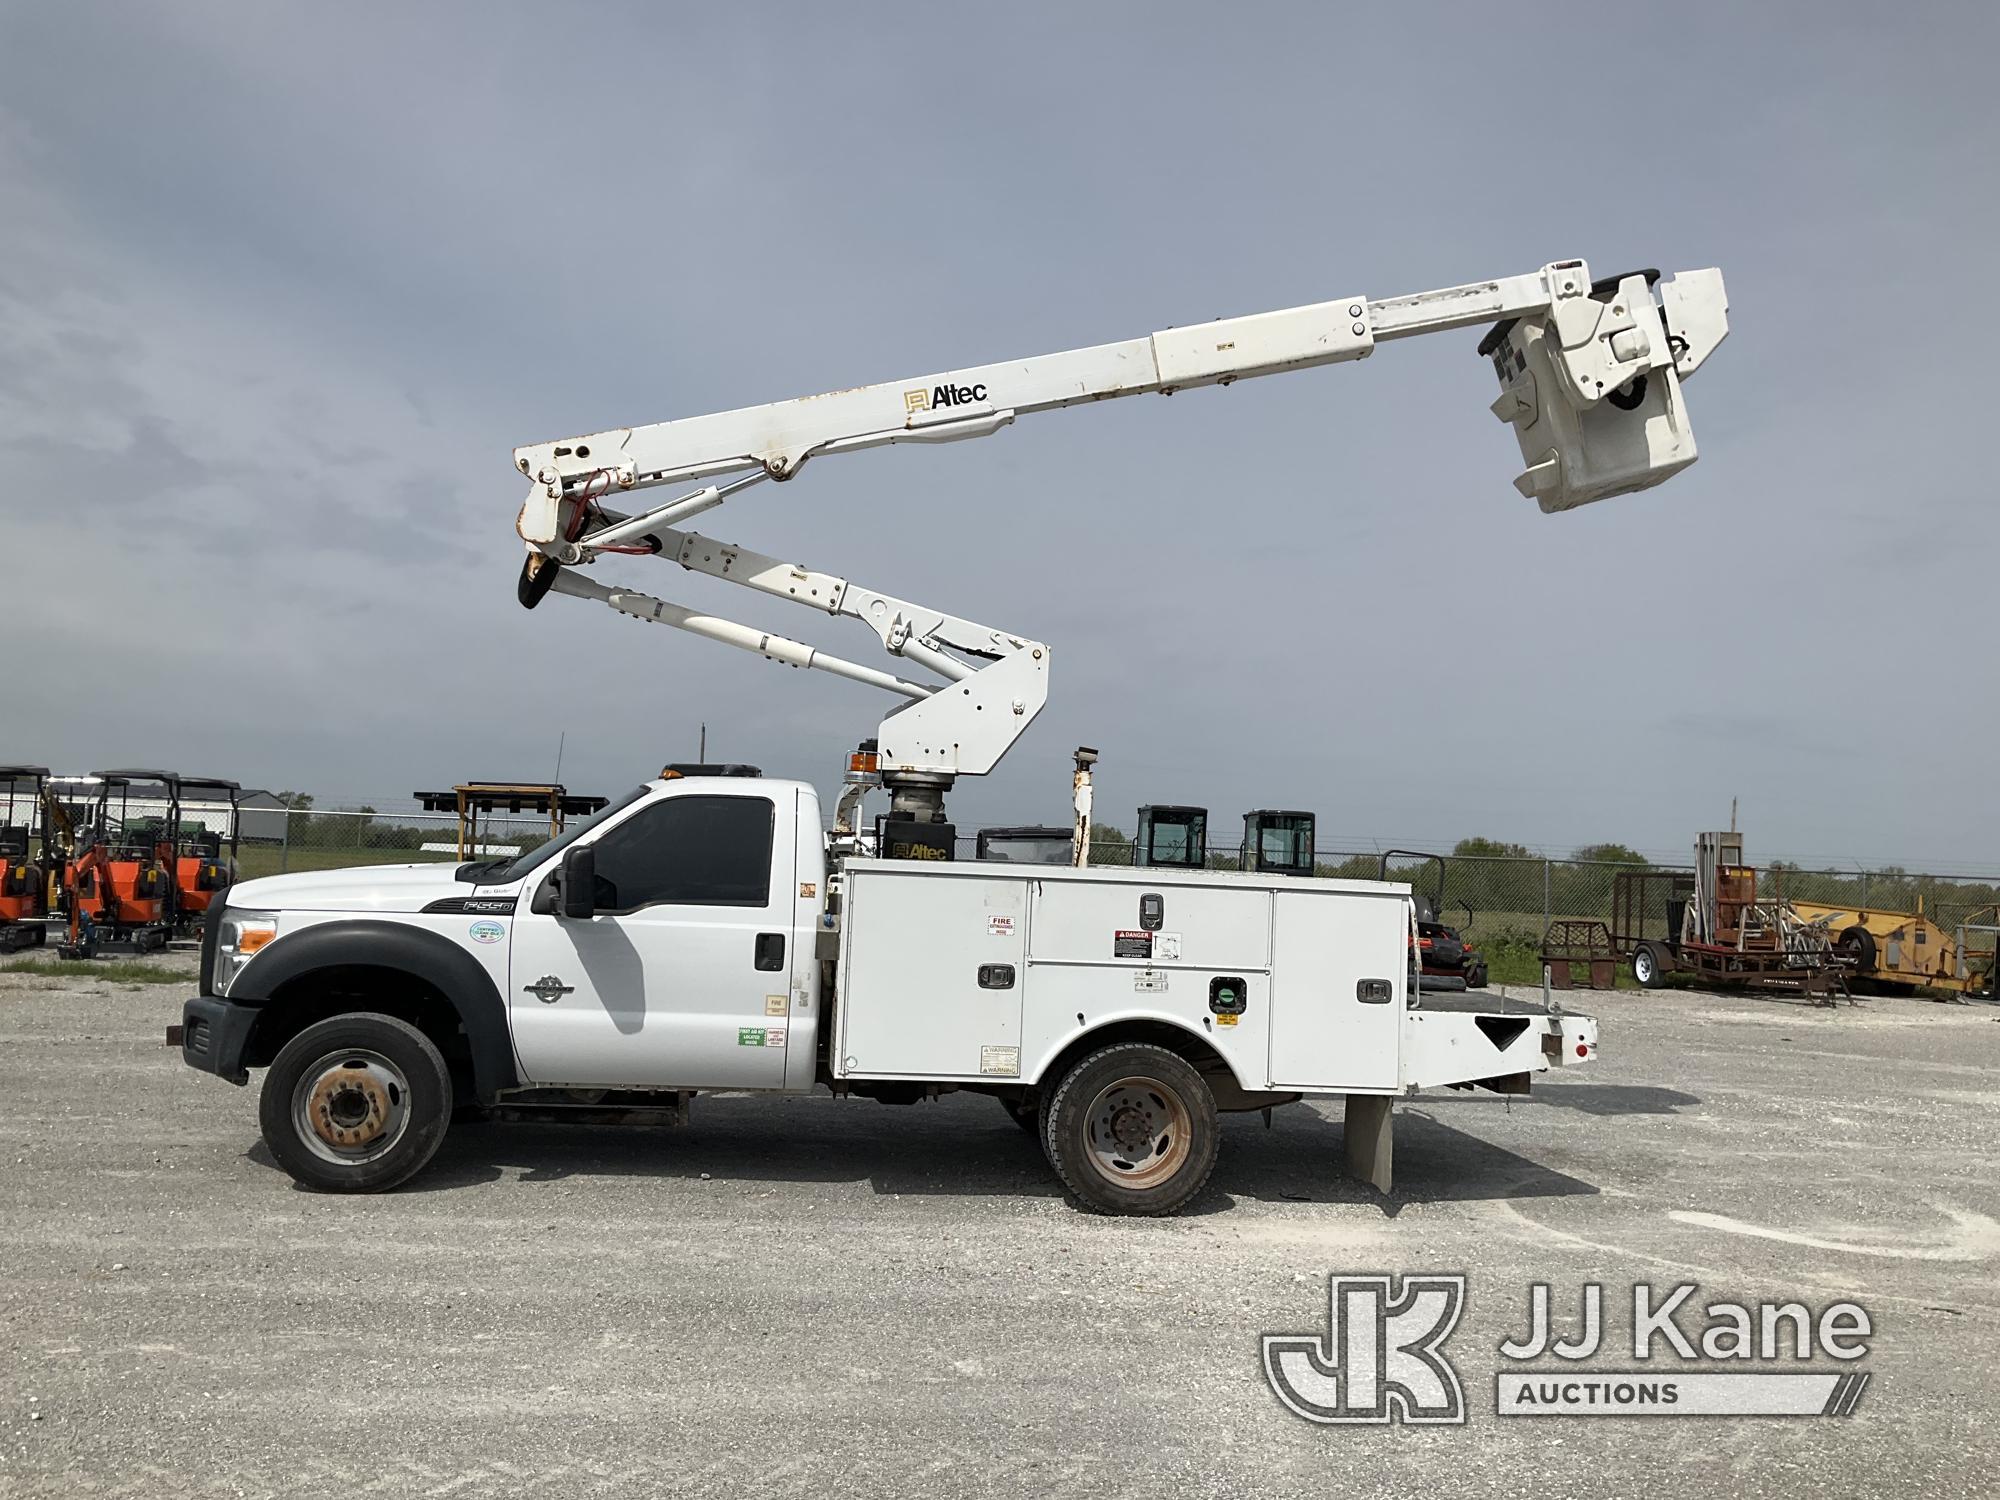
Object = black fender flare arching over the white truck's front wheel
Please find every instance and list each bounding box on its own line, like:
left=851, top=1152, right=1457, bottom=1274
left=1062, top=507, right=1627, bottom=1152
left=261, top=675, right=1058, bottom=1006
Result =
left=230, top=920, right=520, bottom=1104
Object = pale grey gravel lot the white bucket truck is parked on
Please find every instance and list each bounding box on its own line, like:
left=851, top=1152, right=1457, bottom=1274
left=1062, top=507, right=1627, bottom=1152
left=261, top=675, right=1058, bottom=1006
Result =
left=0, top=956, right=2000, bottom=1498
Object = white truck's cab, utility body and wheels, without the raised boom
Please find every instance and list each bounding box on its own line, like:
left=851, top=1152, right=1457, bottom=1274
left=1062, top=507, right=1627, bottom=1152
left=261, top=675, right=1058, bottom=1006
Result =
left=178, top=776, right=1596, bottom=1214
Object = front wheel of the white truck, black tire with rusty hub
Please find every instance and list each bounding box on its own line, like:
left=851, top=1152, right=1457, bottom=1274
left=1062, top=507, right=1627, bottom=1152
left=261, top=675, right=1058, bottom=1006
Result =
left=258, top=1012, right=452, bottom=1192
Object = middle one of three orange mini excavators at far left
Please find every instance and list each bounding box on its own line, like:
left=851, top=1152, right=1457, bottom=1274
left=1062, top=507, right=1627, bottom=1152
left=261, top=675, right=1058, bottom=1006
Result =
left=58, top=770, right=178, bottom=958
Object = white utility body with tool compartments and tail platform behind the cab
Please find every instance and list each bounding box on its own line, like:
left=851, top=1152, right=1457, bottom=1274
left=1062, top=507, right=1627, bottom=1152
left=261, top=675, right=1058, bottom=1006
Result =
left=832, top=860, right=1596, bottom=1096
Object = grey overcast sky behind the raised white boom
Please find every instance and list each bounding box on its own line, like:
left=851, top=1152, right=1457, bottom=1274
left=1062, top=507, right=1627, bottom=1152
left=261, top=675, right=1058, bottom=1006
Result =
left=0, top=0, right=2000, bottom=868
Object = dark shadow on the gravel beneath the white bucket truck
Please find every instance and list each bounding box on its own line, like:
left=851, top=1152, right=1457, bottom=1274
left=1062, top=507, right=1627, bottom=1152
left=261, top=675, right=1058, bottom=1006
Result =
left=246, top=1096, right=1596, bottom=1216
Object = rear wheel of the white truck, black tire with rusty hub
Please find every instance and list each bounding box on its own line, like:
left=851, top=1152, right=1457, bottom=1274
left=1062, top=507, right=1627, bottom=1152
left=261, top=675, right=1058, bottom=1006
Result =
left=1042, top=1042, right=1220, bottom=1216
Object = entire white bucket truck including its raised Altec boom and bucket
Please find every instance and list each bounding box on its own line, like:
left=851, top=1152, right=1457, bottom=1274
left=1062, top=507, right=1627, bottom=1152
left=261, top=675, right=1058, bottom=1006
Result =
left=180, top=260, right=1728, bottom=1214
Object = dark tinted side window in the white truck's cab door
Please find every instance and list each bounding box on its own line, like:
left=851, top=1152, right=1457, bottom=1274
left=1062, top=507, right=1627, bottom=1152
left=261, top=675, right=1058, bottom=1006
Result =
left=596, top=796, right=776, bottom=914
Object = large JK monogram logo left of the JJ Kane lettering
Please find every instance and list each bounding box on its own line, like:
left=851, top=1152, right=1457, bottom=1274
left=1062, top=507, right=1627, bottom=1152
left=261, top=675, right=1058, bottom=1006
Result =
left=1264, top=1276, right=1466, bottom=1424
